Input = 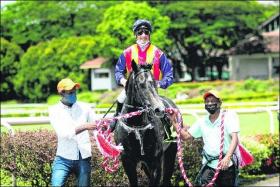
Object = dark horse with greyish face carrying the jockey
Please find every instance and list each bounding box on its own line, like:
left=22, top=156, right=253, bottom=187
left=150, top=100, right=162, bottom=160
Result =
left=114, top=61, right=177, bottom=186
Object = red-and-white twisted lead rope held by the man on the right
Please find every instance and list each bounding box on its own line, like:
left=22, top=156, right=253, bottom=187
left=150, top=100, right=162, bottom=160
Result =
left=166, top=108, right=225, bottom=187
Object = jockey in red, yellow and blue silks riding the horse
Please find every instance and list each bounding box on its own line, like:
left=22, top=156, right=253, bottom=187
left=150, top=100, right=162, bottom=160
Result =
left=111, top=19, right=173, bottom=131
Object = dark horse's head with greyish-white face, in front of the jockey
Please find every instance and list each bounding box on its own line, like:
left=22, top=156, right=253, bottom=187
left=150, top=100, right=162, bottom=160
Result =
left=126, top=60, right=165, bottom=117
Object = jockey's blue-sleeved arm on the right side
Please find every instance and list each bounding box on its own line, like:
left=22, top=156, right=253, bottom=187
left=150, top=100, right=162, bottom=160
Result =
left=159, top=54, right=174, bottom=89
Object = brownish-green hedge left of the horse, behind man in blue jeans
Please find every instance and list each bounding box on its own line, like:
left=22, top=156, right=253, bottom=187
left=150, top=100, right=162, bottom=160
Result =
left=0, top=130, right=128, bottom=186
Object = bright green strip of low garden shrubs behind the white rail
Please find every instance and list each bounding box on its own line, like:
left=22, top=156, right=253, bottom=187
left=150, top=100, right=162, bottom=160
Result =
left=48, top=80, right=279, bottom=105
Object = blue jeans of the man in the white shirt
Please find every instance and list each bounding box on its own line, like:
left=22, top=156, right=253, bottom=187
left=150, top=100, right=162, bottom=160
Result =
left=51, top=154, right=91, bottom=187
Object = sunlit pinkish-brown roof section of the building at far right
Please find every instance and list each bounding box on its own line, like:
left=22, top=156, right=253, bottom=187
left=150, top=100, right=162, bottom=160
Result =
left=262, top=30, right=280, bottom=52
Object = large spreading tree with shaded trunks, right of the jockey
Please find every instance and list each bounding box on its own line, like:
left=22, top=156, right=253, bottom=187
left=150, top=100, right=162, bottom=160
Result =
left=157, top=1, right=276, bottom=80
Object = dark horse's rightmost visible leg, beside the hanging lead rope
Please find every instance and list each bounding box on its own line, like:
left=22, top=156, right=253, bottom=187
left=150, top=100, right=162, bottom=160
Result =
left=162, top=143, right=177, bottom=186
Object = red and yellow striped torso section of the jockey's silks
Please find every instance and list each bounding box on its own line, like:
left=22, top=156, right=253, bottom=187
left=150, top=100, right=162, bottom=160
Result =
left=124, top=44, right=163, bottom=80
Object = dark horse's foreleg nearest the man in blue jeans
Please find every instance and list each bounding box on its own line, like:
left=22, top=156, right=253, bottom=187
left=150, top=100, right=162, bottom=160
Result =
left=121, top=155, right=138, bottom=186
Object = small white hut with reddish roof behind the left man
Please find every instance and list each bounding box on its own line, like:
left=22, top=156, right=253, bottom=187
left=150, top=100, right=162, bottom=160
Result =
left=80, top=57, right=117, bottom=90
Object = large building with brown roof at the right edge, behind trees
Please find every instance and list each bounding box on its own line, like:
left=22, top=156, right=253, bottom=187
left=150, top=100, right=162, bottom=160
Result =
left=229, top=14, right=280, bottom=80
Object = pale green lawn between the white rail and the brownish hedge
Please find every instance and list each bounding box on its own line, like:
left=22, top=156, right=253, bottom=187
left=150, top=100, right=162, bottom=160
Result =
left=1, top=112, right=279, bottom=136
